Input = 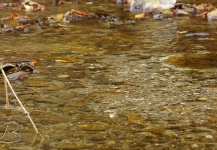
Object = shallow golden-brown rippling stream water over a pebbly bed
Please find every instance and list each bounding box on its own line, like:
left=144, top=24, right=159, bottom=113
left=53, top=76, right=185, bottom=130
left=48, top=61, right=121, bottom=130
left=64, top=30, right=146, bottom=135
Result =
left=0, top=1, right=217, bottom=150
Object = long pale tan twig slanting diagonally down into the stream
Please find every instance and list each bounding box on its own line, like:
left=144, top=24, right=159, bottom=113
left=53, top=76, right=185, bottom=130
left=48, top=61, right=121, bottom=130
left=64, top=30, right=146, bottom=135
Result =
left=1, top=66, right=40, bottom=134
